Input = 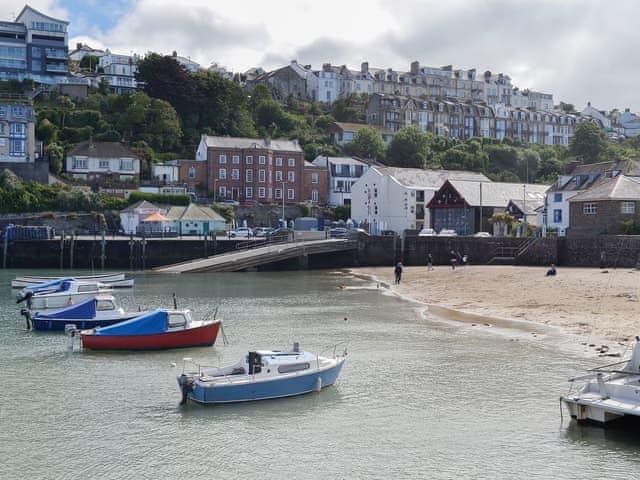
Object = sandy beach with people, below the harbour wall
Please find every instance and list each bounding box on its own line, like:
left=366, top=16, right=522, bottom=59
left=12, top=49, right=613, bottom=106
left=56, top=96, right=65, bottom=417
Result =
left=353, top=265, right=640, bottom=342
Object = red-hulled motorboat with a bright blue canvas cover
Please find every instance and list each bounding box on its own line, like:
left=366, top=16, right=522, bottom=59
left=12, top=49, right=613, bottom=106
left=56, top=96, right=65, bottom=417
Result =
left=79, top=309, right=221, bottom=350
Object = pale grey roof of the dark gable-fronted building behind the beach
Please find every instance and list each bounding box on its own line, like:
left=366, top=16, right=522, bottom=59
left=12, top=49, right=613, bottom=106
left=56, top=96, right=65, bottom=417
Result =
left=449, top=179, right=549, bottom=210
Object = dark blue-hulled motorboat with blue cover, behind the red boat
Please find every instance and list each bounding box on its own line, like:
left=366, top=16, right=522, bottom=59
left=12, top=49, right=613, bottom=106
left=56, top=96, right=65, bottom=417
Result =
left=20, top=295, right=146, bottom=331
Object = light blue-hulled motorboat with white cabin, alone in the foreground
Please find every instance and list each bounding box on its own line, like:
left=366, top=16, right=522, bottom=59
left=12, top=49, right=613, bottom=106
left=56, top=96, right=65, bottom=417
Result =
left=178, top=343, right=347, bottom=404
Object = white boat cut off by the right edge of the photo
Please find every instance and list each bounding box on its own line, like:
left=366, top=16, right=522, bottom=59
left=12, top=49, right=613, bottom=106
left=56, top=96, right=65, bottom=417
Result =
left=560, top=337, right=640, bottom=424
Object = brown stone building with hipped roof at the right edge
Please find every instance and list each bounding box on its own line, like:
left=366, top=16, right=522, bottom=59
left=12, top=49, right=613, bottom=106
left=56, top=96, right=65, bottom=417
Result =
left=567, top=175, right=640, bottom=237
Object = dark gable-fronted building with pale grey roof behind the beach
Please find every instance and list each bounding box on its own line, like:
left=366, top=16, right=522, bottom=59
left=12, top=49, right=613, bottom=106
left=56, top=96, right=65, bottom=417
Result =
left=427, top=179, right=548, bottom=235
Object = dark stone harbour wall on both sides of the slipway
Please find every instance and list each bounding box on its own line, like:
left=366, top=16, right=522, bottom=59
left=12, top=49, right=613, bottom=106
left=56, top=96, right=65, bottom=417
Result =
left=0, top=235, right=640, bottom=270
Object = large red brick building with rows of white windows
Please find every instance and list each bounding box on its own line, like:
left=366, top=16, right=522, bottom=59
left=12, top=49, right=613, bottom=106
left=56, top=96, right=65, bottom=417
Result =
left=180, top=135, right=326, bottom=203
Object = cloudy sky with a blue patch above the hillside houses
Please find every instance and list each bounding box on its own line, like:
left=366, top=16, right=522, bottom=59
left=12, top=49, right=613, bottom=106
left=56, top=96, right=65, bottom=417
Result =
left=0, top=0, right=640, bottom=112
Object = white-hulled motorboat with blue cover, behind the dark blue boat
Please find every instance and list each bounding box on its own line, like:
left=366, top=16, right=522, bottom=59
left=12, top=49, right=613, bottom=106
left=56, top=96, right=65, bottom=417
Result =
left=17, top=277, right=112, bottom=310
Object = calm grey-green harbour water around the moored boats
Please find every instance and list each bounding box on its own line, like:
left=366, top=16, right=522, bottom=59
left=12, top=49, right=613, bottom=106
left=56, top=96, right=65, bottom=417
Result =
left=0, top=271, right=640, bottom=480
